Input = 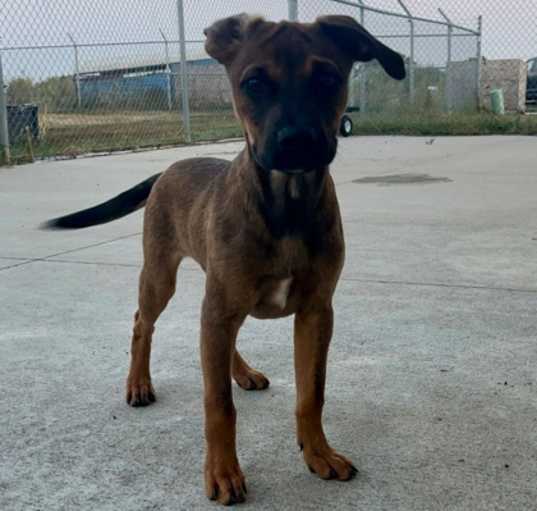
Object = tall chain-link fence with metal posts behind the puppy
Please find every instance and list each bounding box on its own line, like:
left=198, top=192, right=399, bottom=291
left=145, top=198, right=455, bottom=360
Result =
left=0, top=0, right=537, bottom=161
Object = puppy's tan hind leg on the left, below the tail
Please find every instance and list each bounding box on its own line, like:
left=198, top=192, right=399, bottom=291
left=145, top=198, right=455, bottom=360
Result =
left=126, top=250, right=181, bottom=406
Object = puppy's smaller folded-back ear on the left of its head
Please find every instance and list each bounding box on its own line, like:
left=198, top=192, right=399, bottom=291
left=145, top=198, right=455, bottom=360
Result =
left=203, top=13, right=263, bottom=66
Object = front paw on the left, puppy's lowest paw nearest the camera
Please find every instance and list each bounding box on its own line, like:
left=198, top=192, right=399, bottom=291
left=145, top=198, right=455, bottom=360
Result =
left=205, top=463, right=247, bottom=506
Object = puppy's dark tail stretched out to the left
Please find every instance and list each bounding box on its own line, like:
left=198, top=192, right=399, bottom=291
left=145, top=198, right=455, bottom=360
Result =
left=41, top=173, right=161, bottom=229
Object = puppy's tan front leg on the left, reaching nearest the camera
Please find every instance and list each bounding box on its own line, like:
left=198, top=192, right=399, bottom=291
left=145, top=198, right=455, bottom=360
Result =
left=201, top=287, right=246, bottom=505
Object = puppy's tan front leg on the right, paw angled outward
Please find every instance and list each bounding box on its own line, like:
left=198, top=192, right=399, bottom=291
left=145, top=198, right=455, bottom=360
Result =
left=295, top=303, right=357, bottom=481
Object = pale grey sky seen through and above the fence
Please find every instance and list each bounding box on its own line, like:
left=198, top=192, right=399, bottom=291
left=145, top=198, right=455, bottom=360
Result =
left=0, top=0, right=537, bottom=80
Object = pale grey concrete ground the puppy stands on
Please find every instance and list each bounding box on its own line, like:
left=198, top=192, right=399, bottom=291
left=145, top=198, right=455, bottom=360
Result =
left=0, top=137, right=537, bottom=511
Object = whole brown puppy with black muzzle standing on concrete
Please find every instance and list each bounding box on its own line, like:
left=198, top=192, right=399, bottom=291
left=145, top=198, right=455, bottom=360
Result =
left=48, top=15, right=405, bottom=504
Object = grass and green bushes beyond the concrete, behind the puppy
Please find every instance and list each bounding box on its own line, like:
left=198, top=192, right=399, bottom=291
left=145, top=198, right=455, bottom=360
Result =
left=4, top=65, right=537, bottom=165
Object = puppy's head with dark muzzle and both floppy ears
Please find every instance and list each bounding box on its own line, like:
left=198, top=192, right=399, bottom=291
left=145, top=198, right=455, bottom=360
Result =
left=205, top=14, right=405, bottom=173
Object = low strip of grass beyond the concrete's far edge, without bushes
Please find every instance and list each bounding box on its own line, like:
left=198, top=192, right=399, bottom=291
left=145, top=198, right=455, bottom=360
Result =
left=4, top=111, right=537, bottom=164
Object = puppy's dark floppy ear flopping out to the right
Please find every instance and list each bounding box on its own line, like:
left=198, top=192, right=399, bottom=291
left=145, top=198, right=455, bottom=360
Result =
left=317, top=16, right=406, bottom=80
